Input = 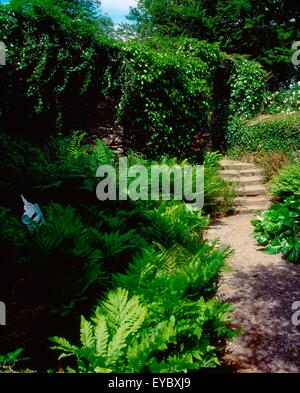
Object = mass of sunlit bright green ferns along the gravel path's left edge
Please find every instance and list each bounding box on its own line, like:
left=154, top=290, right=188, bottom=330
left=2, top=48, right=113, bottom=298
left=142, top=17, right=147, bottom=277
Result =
left=48, top=149, right=235, bottom=372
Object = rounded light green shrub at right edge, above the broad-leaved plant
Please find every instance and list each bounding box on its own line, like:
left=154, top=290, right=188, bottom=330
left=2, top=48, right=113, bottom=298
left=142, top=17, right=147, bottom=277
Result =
left=271, top=162, right=300, bottom=199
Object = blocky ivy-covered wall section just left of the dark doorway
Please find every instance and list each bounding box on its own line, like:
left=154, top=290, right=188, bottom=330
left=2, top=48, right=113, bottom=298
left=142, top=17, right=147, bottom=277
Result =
left=118, top=40, right=219, bottom=159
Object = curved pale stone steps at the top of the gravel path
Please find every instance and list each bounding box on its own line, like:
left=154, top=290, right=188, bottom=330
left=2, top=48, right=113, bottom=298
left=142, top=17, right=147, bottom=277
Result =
left=220, top=160, right=271, bottom=214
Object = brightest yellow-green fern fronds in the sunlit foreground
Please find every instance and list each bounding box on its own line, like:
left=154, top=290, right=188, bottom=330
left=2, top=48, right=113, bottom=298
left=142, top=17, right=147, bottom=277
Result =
left=51, top=288, right=147, bottom=372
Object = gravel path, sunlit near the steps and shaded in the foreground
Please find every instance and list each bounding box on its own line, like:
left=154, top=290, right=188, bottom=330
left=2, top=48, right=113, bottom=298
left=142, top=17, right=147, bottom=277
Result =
left=206, top=214, right=300, bottom=372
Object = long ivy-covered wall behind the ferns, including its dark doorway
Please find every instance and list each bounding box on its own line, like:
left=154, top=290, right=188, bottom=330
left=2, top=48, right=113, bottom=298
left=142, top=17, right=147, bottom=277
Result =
left=0, top=0, right=266, bottom=161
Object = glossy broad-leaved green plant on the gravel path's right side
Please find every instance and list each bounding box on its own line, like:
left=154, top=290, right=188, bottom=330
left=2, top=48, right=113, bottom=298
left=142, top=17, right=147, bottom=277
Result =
left=253, top=196, right=300, bottom=262
